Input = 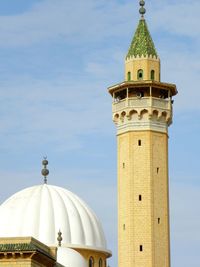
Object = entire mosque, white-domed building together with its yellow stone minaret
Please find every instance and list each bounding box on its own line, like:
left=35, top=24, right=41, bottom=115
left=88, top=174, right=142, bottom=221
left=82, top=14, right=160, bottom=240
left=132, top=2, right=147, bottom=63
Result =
left=0, top=0, right=177, bottom=267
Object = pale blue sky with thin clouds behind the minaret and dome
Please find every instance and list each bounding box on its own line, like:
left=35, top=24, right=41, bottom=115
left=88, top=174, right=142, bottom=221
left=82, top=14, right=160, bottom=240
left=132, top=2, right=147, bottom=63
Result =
left=0, top=0, right=200, bottom=267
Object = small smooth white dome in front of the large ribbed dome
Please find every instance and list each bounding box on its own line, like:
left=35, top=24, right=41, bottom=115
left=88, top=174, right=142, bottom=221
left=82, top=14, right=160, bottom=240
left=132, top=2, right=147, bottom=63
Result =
left=57, top=247, right=88, bottom=267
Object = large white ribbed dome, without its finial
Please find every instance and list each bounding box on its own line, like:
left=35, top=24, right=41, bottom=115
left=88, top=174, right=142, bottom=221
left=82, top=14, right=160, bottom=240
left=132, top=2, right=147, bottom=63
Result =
left=0, top=184, right=107, bottom=251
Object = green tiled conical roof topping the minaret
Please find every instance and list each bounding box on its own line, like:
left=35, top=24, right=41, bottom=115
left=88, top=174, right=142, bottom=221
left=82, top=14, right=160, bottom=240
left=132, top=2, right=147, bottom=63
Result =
left=126, top=19, right=158, bottom=58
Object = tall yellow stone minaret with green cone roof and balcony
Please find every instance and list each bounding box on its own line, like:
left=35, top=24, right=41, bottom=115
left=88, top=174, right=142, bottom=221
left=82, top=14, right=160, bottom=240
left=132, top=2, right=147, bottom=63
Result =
left=108, top=1, right=177, bottom=267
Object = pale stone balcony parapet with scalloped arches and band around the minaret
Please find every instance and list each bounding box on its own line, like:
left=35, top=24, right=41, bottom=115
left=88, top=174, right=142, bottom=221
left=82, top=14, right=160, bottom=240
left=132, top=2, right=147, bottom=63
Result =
left=113, top=98, right=172, bottom=134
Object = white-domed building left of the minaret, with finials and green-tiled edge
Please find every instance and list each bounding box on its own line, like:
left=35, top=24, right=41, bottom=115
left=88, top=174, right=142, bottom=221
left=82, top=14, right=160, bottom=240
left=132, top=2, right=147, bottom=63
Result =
left=0, top=159, right=111, bottom=267
